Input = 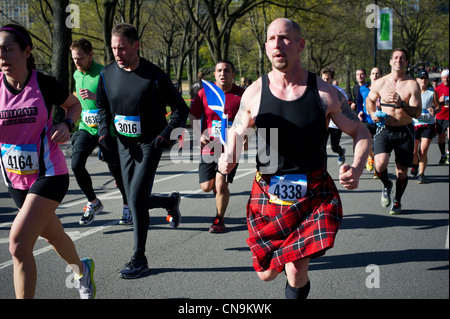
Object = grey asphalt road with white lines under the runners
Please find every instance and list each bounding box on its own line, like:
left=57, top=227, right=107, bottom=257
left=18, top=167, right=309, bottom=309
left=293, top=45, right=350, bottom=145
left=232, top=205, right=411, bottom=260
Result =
left=0, top=130, right=449, bottom=304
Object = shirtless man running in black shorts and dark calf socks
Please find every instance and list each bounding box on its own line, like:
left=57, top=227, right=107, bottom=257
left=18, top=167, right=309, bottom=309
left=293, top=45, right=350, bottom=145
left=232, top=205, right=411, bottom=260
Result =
left=366, top=49, right=422, bottom=215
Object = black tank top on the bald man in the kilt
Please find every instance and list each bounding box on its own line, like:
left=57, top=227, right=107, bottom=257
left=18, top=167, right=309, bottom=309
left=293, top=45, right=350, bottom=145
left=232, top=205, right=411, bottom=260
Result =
left=255, top=72, right=327, bottom=175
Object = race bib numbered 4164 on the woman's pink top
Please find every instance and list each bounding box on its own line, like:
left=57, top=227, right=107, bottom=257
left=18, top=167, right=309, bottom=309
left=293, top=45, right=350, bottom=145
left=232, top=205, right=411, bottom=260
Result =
left=1, top=144, right=39, bottom=175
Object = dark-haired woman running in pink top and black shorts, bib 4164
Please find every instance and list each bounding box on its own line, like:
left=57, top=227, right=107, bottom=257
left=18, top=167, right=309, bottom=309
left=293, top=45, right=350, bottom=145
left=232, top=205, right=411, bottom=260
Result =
left=0, top=24, right=95, bottom=298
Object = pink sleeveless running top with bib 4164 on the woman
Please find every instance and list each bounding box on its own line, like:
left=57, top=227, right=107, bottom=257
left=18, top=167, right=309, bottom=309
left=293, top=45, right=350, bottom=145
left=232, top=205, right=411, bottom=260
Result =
left=0, top=70, right=68, bottom=190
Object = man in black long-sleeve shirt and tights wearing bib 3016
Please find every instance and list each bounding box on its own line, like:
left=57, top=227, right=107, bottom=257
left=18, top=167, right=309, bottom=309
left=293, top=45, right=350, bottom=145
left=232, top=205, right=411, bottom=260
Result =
left=97, top=24, right=189, bottom=279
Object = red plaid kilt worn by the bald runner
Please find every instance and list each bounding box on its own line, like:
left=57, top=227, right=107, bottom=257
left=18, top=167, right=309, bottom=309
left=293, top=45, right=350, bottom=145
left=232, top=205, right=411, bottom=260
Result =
left=247, top=170, right=342, bottom=272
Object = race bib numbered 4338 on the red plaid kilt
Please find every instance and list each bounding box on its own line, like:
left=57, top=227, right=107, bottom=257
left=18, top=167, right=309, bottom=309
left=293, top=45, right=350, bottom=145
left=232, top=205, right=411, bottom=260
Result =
left=269, top=174, right=308, bottom=205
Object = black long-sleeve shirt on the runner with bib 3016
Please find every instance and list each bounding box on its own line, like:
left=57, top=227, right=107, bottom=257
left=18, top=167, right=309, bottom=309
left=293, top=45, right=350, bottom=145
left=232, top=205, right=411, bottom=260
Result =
left=97, top=58, right=189, bottom=143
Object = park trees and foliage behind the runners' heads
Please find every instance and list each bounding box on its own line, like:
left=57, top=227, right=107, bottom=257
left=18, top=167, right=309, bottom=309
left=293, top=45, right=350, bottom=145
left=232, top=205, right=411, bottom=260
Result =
left=0, top=0, right=449, bottom=121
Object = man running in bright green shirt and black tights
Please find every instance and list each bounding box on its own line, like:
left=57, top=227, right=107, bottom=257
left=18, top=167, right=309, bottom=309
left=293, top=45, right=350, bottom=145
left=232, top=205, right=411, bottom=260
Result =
left=70, top=39, right=132, bottom=225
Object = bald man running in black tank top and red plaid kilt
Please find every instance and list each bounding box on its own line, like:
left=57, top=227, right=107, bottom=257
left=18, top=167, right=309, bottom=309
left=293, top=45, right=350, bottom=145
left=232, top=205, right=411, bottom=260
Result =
left=219, top=19, right=371, bottom=299
